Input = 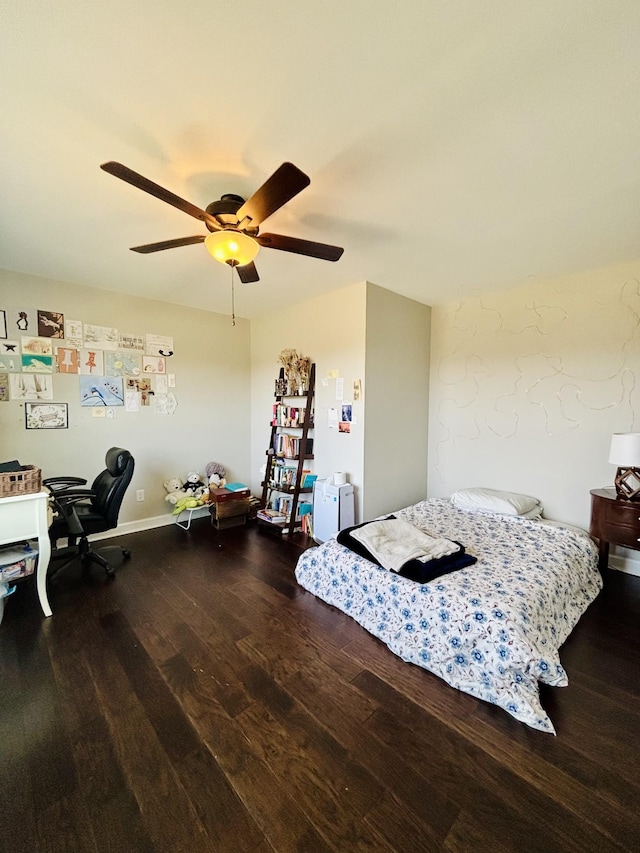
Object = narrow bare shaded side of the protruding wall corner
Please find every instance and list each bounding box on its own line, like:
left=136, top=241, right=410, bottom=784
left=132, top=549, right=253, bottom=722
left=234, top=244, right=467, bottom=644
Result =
left=364, top=283, right=431, bottom=518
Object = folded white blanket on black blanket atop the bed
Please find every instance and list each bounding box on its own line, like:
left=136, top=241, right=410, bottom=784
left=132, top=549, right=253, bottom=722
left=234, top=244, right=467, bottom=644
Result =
left=351, top=518, right=460, bottom=572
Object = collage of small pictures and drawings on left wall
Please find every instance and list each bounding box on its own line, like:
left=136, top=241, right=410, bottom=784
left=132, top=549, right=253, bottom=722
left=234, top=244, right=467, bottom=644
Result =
left=0, top=306, right=177, bottom=429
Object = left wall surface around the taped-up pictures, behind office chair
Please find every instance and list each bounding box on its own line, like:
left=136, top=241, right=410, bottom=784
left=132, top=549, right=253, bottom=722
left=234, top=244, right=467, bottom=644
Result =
left=0, top=270, right=251, bottom=522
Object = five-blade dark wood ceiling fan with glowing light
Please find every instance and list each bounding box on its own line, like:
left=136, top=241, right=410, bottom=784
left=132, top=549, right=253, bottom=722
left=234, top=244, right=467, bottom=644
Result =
left=100, top=161, right=344, bottom=284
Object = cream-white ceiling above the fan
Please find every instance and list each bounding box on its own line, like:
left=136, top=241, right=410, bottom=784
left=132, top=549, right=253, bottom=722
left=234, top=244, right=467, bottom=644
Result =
left=0, top=0, right=640, bottom=317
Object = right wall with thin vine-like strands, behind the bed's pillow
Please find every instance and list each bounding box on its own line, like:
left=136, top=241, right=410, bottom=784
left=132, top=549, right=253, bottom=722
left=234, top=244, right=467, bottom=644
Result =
left=429, top=263, right=640, bottom=544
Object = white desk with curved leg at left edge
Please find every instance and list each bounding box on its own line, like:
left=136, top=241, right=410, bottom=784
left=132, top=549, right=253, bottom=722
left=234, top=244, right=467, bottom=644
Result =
left=0, top=491, right=51, bottom=616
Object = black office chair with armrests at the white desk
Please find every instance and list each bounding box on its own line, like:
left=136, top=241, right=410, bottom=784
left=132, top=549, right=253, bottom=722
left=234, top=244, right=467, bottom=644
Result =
left=42, top=447, right=134, bottom=578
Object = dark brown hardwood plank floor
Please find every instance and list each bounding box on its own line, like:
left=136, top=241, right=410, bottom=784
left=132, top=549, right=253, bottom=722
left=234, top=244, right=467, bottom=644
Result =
left=0, top=519, right=640, bottom=853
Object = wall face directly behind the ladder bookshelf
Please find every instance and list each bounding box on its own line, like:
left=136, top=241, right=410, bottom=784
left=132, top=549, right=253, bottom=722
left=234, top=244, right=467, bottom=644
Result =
left=251, top=282, right=366, bottom=517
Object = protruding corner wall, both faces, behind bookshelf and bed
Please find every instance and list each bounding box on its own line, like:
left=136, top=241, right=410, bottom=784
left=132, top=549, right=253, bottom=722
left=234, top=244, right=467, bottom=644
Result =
left=251, top=282, right=430, bottom=520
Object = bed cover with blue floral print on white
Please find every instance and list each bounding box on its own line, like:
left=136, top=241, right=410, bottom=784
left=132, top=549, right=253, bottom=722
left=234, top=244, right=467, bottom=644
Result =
left=296, top=498, right=602, bottom=734
